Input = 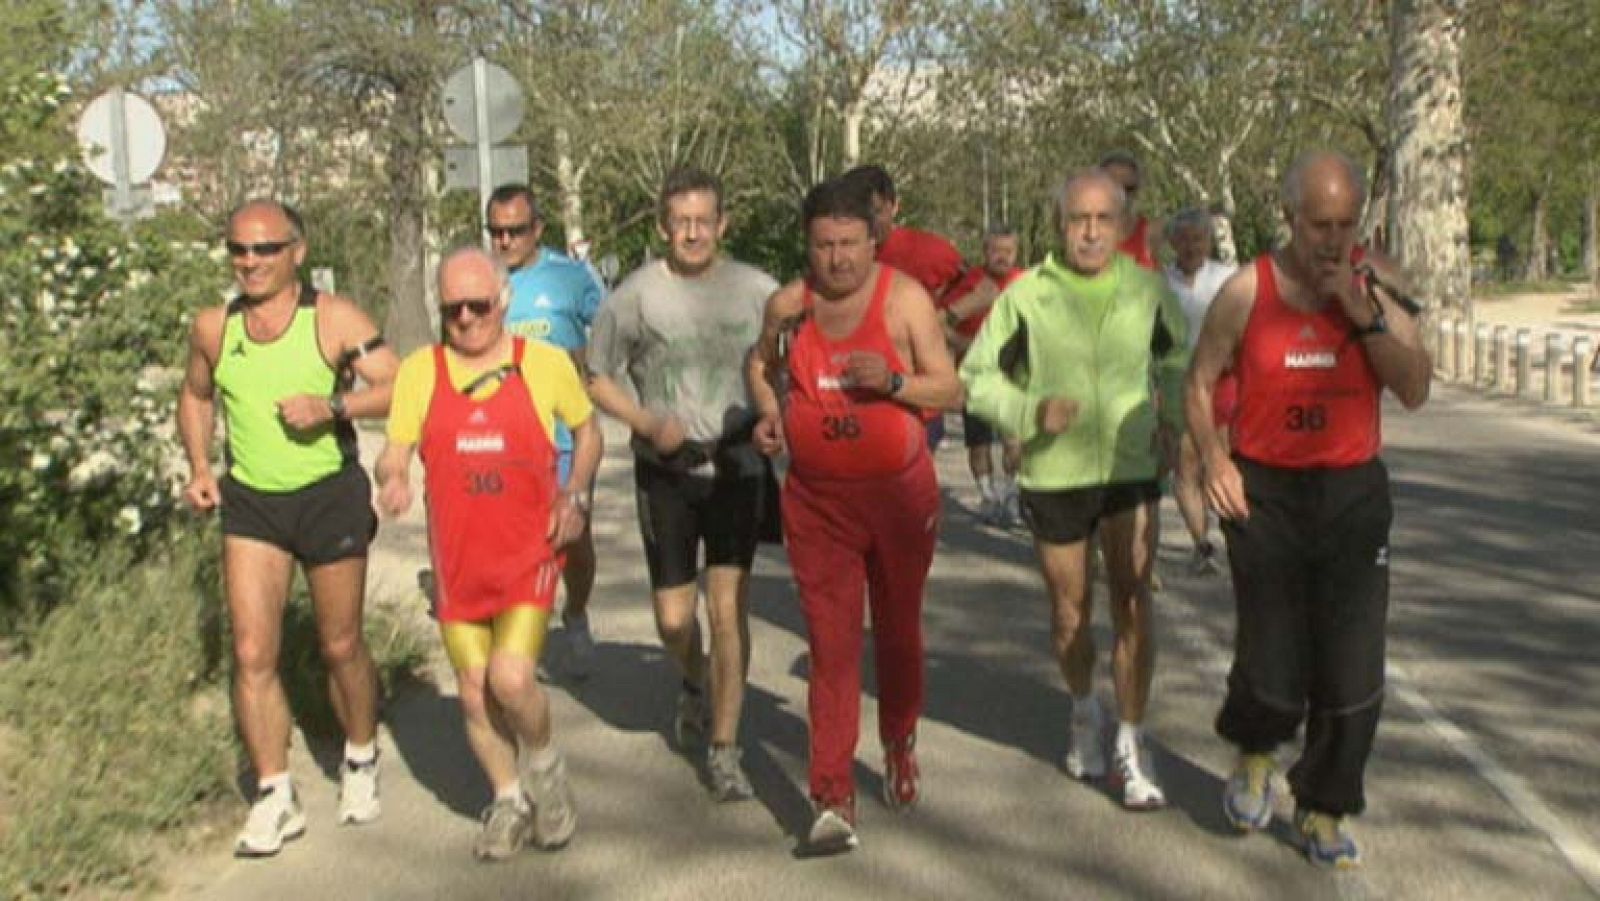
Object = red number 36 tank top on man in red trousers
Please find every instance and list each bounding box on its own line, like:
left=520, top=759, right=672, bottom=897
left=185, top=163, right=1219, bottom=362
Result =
left=784, top=266, right=926, bottom=479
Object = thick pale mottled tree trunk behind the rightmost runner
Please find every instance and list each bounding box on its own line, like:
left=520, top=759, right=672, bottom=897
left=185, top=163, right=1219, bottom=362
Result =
left=1389, top=0, right=1472, bottom=320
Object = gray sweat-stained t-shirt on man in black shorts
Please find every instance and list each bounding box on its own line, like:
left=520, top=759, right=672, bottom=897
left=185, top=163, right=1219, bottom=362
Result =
left=589, top=258, right=778, bottom=457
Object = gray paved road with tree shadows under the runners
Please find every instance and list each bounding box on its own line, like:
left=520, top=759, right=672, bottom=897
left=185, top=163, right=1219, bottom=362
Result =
left=170, top=389, right=1600, bottom=901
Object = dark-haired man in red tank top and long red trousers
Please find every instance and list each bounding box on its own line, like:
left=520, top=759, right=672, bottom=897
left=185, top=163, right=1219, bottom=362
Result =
left=749, top=179, right=960, bottom=853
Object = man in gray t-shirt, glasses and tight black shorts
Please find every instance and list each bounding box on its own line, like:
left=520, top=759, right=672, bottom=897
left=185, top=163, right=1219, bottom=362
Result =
left=589, top=170, right=778, bottom=800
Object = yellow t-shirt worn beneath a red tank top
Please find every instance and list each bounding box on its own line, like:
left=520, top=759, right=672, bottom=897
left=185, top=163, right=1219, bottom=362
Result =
left=389, top=341, right=594, bottom=445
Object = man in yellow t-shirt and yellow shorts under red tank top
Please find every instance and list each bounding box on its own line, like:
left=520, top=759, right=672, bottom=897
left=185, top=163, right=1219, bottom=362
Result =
left=378, top=248, right=602, bottom=859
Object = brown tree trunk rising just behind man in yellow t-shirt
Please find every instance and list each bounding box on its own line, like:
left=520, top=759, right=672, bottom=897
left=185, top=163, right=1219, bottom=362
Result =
left=384, top=80, right=434, bottom=355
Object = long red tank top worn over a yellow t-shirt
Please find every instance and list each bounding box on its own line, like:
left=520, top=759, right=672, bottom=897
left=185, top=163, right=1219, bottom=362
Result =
left=421, top=338, right=562, bottom=623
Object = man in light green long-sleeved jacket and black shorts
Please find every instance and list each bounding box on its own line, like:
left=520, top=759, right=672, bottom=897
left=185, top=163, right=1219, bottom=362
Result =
left=960, top=170, right=1187, bottom=810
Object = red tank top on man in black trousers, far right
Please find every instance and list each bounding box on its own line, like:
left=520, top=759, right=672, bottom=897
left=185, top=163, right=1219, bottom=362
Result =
left=1234, top=248, right=1382, bottom=469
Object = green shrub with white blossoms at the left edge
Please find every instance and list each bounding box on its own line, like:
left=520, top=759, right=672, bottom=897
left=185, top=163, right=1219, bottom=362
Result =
left=0, top=74, right=226, bottom=618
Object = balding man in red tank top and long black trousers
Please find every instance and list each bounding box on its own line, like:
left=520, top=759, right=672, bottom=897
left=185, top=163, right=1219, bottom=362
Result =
left=1186, top=152, right=1432, bottom=867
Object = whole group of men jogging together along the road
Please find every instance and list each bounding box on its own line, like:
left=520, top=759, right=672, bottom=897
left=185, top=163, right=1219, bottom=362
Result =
left=178, top=152, right=1430, bottom=866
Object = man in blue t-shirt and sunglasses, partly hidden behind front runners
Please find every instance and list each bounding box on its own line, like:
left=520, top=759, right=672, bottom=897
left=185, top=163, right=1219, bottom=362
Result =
left=485, top=184, right=605, bottom=677
